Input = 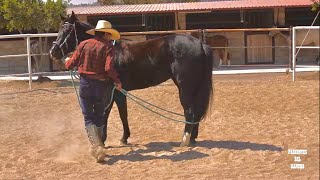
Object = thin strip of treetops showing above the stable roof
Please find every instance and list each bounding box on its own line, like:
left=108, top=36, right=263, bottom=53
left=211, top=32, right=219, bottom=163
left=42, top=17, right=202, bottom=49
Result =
left=98, top=0, right=199, bottom=5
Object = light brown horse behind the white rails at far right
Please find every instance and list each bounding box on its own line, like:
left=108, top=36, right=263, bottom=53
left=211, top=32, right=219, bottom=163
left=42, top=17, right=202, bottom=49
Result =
left=269, top=30, right=320, bottom=65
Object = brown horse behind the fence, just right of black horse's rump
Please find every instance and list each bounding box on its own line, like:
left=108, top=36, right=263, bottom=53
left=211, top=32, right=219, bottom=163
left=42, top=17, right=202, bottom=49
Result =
left=206, top=35, right=231, bottom=68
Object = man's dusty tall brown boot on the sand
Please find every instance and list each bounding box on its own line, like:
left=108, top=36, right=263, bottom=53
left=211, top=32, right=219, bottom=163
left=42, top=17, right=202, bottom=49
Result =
left=86, top=125, right=106, bottom=163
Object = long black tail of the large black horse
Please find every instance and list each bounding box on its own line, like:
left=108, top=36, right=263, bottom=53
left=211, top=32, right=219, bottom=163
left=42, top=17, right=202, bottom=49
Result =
left=196, top=44, right=213, bottom=120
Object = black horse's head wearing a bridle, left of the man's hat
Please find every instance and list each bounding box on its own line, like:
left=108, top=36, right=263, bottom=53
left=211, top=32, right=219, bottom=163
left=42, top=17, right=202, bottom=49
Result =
left=49, top=12, right=90, bottom=68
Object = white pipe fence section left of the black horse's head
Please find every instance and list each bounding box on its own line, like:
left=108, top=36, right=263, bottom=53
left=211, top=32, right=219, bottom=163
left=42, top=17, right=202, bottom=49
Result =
left=0, top=33, right=58, bottom=89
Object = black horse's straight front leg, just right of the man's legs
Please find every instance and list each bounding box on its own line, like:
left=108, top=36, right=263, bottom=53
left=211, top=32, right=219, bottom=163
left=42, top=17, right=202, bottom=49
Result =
left=114, top=91, right=130, bottom=145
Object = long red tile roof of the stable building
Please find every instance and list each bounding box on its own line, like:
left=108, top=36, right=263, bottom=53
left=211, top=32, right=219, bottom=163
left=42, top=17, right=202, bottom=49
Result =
left=68, top=0, right=312, bottom=15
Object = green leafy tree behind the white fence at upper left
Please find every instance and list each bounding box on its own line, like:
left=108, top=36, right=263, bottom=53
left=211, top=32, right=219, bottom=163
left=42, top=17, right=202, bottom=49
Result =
left=0, top=0, right=67, bottom=33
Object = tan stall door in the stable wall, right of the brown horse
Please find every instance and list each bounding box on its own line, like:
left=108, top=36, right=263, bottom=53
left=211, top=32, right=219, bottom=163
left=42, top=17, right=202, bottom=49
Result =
left=246, top=34, right=274, bottom=64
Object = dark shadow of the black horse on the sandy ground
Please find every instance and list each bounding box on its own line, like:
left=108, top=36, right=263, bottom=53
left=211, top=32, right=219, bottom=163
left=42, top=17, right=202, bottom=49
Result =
left=105, top=140, right=283, bottom=165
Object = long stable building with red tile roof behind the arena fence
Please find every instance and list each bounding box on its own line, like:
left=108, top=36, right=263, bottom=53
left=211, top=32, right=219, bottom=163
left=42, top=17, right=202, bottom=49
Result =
left=68, top=0, right=319, bottom=64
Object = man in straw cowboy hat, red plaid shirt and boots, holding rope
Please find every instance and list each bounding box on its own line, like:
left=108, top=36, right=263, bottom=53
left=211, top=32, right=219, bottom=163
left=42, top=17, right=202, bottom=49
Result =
left=65, top=20, right=122, bottom=162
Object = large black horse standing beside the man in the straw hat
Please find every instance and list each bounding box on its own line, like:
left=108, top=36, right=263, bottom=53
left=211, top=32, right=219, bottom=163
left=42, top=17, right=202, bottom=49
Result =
left=49, top=12, right=213, bottom=146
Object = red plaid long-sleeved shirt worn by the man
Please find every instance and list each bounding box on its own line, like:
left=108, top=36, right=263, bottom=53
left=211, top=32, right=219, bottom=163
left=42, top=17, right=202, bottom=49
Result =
left=65, top=38, right=120, bottom=83
